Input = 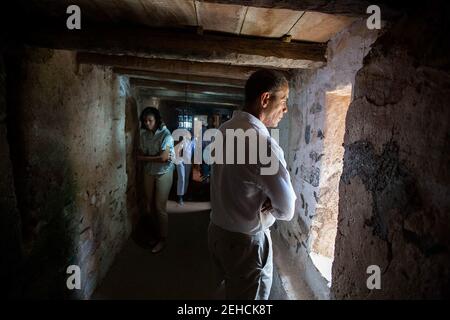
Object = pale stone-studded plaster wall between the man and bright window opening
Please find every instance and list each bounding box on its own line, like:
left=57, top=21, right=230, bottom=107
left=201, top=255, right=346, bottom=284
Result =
left=279, top=21, right=377, bottom=255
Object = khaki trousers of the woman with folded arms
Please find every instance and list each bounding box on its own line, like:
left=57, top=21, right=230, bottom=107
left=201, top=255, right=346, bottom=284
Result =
left=144, top=170, right=173, bottom=238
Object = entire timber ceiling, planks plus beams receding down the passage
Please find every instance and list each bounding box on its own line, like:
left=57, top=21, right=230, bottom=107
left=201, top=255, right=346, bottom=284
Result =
left=19, top=0, right=363, bottom=108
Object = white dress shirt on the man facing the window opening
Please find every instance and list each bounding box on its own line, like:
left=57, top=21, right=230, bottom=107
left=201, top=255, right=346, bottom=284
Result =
left=210, top=111, right=297, bottom=234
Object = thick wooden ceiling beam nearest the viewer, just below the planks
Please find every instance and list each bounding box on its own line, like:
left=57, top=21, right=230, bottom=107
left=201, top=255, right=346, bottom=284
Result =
left=23, top=25, right=326, bottom=69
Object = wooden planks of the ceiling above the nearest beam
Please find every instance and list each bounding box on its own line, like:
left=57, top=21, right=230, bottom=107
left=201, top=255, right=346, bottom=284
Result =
left=27, top=0, right=358, bottom=43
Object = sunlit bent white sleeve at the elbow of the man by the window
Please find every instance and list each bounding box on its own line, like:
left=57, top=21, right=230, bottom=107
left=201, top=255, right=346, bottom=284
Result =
left=259, top=162, right=297, bottom=221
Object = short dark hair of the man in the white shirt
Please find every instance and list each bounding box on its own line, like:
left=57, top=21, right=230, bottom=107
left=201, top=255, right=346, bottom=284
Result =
left=245, top=69, right=288, bottom=105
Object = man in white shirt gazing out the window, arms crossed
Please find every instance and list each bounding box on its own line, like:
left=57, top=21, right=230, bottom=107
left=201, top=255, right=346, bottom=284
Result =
left=208, top=69, right=296, bottom=300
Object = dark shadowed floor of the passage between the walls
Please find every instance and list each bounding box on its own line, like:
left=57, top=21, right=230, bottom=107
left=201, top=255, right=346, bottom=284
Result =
left=92, top=201, right=298, bottom=300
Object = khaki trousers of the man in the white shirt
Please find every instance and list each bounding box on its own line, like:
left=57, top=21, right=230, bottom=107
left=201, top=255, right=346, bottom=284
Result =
left=208, top=223, right=273, bottom=300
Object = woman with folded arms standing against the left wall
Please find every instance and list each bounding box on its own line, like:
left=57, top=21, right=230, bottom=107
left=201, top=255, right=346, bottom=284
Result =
left=137, top=107, right=175, bottom=253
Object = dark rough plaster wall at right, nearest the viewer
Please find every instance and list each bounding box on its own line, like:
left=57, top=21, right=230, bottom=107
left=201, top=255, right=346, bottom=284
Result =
left=332, top=4, right=450, bottom=299
